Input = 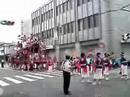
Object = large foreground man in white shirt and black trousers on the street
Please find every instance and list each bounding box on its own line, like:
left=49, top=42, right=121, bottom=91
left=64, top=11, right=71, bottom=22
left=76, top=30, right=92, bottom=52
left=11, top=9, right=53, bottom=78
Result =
left=62, top=55, right=71, bottom=95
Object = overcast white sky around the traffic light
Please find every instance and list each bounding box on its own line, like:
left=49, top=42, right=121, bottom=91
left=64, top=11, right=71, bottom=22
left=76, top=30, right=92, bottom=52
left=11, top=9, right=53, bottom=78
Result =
left=0, top=0, right=48, bottom=42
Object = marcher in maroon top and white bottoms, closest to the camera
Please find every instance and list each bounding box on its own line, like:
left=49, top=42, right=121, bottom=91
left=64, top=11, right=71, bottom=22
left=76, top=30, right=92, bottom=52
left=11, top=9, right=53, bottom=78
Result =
left=92, top=52, right=103, bottom=85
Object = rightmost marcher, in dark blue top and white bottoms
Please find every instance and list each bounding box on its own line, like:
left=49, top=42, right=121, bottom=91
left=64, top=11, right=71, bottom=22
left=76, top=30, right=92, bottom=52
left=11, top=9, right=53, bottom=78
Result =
left=120, top=53, right=129, bottom=79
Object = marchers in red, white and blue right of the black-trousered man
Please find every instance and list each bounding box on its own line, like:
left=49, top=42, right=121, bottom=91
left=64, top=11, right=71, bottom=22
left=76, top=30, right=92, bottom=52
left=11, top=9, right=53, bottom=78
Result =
left=62, top=52, right=129, bottom=85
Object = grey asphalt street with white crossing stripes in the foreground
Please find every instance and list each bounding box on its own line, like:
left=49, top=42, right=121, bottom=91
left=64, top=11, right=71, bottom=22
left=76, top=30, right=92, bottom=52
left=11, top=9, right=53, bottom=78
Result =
left=0, top=68, right=130, bottom=97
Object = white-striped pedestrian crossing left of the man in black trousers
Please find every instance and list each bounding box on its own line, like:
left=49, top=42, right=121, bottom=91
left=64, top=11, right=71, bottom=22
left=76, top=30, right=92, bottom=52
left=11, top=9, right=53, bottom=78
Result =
left=0, top=71, right=63, bottom=87
